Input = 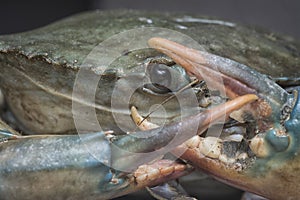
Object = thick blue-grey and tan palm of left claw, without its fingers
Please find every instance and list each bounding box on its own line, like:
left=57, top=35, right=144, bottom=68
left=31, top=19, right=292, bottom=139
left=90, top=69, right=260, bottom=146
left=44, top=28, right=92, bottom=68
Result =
left=0, top=134, right=116, bottom=199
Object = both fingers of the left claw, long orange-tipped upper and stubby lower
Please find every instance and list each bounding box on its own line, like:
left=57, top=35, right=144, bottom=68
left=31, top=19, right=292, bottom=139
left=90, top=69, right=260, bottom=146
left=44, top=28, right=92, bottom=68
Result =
left=111, top=94, right=257, bottom=198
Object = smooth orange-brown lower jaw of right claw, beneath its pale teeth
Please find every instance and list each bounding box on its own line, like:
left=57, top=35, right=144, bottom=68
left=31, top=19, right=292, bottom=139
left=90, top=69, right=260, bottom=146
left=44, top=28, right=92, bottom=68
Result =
left=174, top=94, right=300, bottom=200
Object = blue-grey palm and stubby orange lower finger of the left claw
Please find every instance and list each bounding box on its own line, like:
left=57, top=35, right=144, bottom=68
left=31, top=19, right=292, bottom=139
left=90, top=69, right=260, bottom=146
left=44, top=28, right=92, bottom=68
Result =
left=0, top=133, right=191, bottom=200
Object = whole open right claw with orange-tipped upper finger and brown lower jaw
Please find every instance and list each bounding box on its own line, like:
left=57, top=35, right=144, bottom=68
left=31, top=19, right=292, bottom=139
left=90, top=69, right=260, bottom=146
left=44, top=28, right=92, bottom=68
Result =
left=148, top=38, right=300, bottom=199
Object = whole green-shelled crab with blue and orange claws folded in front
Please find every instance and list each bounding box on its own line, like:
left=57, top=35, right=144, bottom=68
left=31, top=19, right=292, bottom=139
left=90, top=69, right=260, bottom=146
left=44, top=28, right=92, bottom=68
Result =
left=0, top=11, right=300, bottom=199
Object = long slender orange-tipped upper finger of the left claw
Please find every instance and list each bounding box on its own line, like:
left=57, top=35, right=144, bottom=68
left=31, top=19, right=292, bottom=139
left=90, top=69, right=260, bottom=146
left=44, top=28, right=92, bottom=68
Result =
left=112, top=94, right=257, bottom=171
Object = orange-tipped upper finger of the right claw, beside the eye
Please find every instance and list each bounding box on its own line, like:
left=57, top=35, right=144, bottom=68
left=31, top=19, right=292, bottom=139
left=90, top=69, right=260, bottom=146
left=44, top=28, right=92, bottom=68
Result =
left=148, top=38, right=289, bottom=117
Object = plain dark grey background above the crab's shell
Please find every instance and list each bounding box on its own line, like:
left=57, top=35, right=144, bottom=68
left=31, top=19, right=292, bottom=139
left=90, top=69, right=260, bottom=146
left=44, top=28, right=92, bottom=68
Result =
left=0, top=0, right=300, bottom=38
